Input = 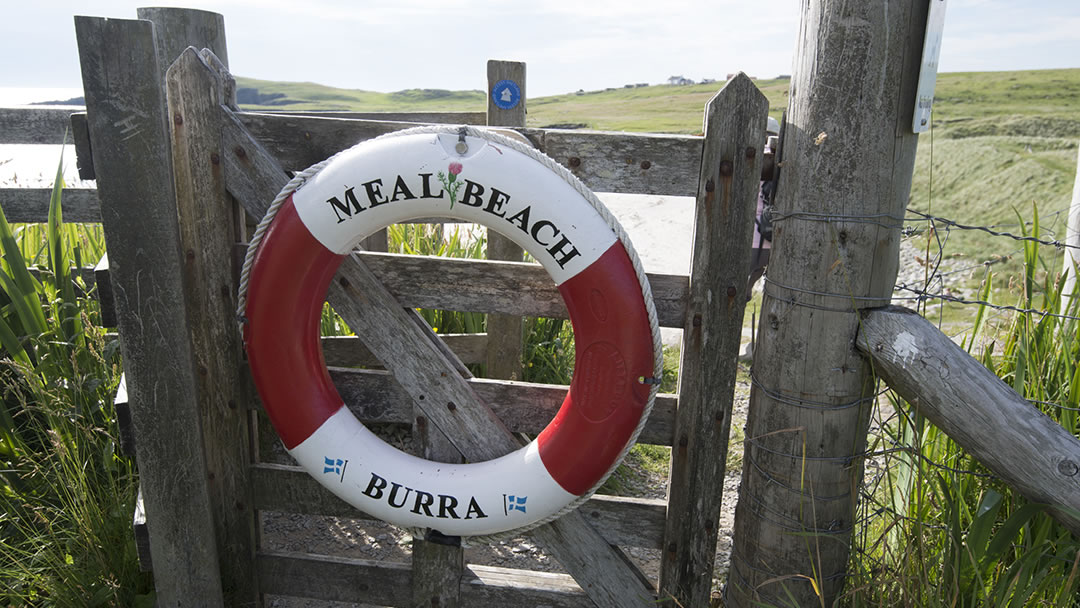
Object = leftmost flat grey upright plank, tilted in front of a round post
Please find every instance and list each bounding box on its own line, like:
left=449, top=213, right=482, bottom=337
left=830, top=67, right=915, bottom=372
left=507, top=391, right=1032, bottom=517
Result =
left=76, top=16, right=221, bottom=606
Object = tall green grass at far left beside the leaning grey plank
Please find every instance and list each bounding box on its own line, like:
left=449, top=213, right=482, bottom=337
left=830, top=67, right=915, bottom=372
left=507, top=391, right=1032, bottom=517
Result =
left=0, top=159, right=152, bottom=606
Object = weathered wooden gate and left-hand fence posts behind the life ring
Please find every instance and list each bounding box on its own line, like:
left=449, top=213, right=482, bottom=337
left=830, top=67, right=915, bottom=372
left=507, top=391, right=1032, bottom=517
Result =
left=0, top=9, right=767, bottom=607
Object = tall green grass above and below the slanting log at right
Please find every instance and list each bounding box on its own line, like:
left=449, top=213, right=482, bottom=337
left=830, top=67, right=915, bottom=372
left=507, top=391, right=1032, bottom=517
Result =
left=843, top=240, right=1080, bottom=607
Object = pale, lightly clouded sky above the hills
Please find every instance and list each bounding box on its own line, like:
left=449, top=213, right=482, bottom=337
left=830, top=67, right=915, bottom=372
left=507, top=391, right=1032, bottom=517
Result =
left=0, top=0, right=1080, bottom=104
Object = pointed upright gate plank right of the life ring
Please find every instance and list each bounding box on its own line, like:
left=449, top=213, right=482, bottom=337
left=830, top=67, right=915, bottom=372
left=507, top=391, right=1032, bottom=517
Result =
left=660, top=72, right=769, bottom=606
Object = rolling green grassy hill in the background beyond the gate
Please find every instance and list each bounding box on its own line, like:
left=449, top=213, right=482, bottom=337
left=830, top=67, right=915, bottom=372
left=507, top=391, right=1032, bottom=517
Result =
left=238, top=69, right=1080, bottom=289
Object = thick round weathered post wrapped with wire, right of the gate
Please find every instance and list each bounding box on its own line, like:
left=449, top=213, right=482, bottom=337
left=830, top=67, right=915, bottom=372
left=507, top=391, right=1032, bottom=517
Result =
left=726, top=0, right=928, bottom=608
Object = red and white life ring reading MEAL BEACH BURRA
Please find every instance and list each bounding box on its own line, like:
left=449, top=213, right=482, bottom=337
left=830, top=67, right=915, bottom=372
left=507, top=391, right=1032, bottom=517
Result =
left=241, top=127, right=662, bottom=536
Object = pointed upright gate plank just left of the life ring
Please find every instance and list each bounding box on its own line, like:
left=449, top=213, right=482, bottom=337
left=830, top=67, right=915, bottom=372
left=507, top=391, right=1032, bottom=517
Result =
left=166, top=46, right=258, bottom=606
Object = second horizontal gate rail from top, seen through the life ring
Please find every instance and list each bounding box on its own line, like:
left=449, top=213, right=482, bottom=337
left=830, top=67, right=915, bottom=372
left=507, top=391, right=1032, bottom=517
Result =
left=357, top=253, right=690, bottom=327
